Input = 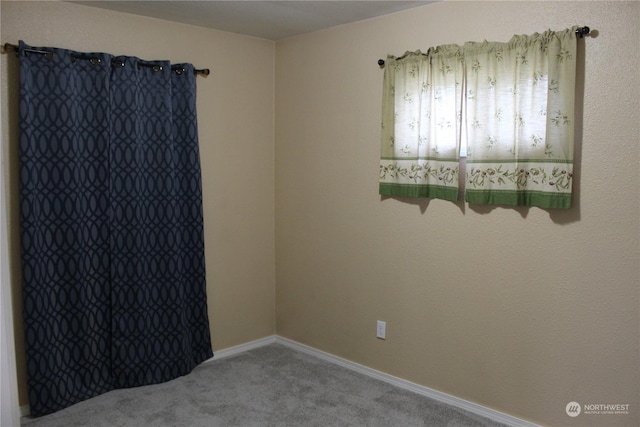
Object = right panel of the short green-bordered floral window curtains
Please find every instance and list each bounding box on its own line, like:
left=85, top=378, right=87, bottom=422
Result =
left=464, top=27, right=577, bottom=208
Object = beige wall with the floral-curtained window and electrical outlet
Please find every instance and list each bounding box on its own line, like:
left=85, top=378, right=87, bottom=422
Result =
left=276, top=1, right=640, bottom=426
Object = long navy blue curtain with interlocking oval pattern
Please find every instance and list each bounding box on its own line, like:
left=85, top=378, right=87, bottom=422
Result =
left=19, top=42, right=213, bottom=416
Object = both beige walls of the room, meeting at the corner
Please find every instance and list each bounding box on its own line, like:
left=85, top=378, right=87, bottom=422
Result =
left=0, top=1, right=640, bottom=426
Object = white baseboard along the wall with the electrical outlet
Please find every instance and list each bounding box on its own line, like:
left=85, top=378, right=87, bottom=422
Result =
left=275, top=336, right=538, bottom=427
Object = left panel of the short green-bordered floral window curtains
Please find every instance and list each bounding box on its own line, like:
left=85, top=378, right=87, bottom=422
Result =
left=379, top=45, right=463, bottom=201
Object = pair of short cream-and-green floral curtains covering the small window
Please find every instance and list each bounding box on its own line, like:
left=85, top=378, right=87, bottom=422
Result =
left=380, top=27, right=577, bottom=208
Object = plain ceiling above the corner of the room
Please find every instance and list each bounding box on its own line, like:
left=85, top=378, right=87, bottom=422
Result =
left=73, top=0, right=434, bottom=40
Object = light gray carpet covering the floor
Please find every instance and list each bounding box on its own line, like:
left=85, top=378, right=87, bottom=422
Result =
left=22, top=344, right=510, bottom=427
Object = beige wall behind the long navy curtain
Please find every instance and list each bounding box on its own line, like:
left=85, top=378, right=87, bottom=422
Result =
left=0, top=1, right=275, bottom=405
